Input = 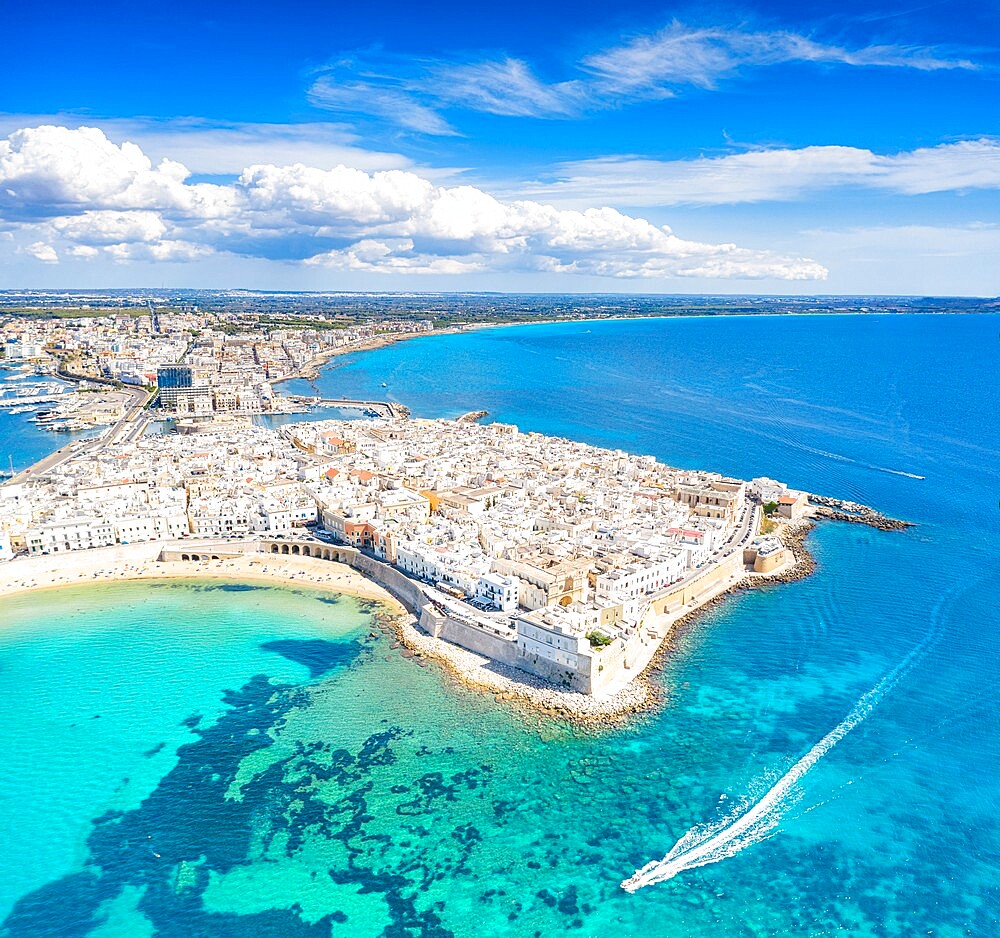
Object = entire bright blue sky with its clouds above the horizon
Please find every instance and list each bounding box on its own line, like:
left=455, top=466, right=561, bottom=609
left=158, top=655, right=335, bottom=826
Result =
left=0, top=0, right=1000, bottom=295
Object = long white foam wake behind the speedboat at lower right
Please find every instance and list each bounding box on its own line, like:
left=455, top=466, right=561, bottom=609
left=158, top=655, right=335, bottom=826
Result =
left=621, top=629, right=939, bottom=893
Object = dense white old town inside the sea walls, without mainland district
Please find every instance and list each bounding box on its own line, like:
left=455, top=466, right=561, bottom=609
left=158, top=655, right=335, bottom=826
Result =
left=0, top=384, right=806, bottom=693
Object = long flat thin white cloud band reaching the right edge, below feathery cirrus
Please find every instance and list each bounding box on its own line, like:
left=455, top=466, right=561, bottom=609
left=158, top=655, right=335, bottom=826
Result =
left=517, top=138, right=1000, bottom=208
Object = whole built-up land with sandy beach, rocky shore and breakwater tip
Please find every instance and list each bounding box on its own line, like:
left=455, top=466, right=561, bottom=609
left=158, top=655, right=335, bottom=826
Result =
left=0, top=304, right=899, bottom=719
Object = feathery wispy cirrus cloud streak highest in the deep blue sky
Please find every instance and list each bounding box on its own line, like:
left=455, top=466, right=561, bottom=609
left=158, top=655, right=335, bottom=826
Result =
left=308, top=21, right=978, bottom=136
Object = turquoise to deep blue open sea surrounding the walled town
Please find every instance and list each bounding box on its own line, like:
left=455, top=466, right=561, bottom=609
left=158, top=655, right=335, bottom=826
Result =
left=0, top=315, right=1000, bottom=938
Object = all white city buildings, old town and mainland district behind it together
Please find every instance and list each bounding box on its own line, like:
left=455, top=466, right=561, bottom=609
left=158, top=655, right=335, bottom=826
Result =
left=0, top=303, right=807, bottom=693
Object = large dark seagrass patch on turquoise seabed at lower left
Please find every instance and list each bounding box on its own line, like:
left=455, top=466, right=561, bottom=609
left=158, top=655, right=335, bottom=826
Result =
left=0, top=660, right=512, bottom=938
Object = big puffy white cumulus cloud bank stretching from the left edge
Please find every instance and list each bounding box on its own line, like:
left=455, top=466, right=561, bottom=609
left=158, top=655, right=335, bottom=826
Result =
left=0, top=127, right=826, bottom=280
